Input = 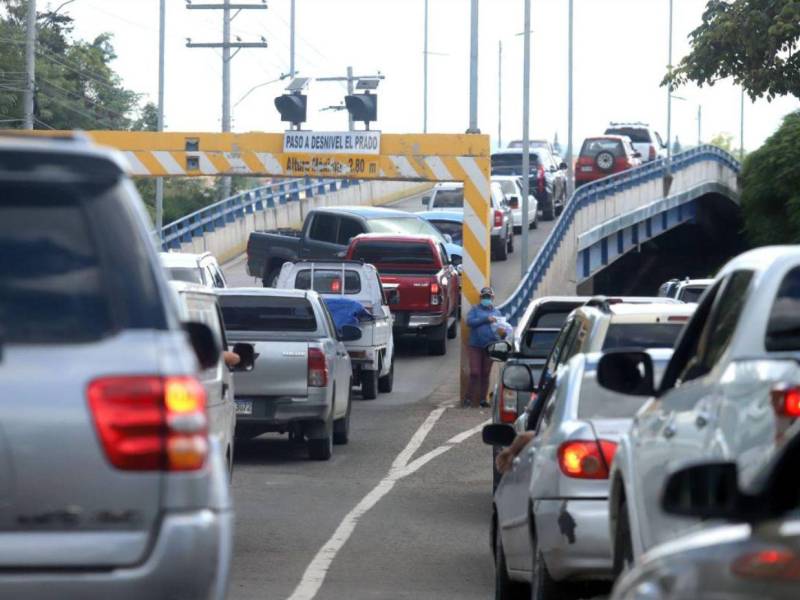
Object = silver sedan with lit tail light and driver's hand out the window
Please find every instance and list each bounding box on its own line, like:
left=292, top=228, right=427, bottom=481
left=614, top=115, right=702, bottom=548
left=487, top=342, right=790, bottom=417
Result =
left=484, top=349, right=672, bottom=600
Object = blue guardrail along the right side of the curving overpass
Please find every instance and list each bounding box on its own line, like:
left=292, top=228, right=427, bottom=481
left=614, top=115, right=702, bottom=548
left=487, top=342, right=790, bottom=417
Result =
left=499, top=145, right=740, bottom=325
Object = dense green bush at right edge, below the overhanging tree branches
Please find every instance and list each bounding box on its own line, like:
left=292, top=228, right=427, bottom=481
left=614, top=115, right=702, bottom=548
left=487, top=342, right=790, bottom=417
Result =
left=740, top=111, right=800, bottom=246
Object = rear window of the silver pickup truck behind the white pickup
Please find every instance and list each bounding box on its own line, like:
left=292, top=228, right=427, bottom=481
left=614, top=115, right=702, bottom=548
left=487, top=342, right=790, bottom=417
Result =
left=220, top=295, right=317, bottom=331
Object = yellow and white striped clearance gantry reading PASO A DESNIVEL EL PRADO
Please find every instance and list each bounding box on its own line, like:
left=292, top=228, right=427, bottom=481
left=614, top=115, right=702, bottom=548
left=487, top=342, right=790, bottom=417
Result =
left=21, top=130, right=491, bottom=398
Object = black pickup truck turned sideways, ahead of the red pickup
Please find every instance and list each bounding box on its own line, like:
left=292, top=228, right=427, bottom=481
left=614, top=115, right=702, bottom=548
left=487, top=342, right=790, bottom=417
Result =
left=247, top=206, right=460, bottom=287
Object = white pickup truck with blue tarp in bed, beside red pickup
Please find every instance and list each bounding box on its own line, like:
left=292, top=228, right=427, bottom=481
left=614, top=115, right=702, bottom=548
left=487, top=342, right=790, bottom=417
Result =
left=275, top=260, right=394, bottom=400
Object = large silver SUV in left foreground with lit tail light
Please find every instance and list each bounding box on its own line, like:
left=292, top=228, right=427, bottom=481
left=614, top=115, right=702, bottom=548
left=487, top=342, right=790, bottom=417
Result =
left=0, top=138, right=233, bottom=600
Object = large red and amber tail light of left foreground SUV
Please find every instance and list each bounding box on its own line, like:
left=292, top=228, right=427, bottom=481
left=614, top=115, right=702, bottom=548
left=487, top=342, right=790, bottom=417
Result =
left=87, top=376, right=208, bottom=471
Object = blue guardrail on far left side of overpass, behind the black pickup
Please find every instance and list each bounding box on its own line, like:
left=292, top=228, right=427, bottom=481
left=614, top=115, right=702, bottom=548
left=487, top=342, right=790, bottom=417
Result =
left=161, top=177, right=362, bottom=250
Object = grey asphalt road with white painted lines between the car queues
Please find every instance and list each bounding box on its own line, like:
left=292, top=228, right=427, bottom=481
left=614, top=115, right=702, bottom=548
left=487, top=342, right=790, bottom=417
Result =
left=225, top=197, right=552, bottom=600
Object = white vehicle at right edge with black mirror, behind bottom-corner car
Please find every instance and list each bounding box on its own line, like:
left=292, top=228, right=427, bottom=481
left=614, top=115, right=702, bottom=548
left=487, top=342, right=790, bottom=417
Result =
left=598, top=246, right=800, bottom=572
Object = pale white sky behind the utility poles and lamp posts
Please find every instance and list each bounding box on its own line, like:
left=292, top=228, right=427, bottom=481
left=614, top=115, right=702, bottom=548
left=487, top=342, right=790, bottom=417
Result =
left=48, top=0, right=800, bottom=150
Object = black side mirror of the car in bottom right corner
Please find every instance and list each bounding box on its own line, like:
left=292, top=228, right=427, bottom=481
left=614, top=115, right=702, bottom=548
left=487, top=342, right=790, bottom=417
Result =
left=661, top=462, right=751, bottom=521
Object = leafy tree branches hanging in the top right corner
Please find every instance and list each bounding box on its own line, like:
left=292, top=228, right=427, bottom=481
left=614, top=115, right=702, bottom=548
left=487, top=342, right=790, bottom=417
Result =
left=662, top=0, right=800, bottom=100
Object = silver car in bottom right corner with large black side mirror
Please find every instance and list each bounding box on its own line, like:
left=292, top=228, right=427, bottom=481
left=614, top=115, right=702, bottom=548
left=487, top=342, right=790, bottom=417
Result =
left=612, top=427, right=800, bottom=600
